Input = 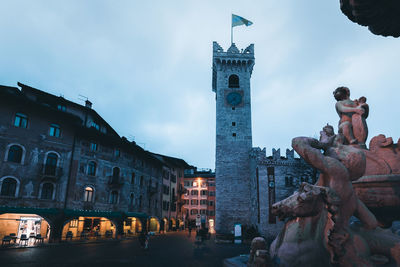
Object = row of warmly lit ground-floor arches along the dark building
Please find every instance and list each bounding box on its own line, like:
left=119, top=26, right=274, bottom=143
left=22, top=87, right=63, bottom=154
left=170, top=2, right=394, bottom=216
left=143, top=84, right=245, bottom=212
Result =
left=0, top=213, right=183, bottom=245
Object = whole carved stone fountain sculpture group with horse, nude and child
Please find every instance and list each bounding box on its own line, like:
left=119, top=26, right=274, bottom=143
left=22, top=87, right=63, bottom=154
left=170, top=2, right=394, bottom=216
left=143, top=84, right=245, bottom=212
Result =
left=256, top=87, right=400, bottom=267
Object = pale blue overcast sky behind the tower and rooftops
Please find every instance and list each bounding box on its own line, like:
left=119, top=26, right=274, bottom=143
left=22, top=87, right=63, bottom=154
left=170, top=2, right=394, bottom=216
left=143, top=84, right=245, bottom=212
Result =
left=0, top=0, right=400, bottom=169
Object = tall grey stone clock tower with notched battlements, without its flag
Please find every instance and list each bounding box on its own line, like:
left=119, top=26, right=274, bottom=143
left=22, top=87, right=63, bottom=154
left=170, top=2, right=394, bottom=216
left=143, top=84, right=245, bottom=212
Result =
left=212, top=42, right=254, bottom=234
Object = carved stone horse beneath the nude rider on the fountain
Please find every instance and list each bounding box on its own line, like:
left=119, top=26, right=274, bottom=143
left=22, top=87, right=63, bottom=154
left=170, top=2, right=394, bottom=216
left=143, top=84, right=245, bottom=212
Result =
left=270, top=183, right=400, bottom=267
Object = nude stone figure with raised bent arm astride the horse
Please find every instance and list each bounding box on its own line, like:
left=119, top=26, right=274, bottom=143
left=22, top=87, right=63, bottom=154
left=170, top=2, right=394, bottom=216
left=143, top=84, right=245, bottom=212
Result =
left=292, top=128, right=378, bottom=264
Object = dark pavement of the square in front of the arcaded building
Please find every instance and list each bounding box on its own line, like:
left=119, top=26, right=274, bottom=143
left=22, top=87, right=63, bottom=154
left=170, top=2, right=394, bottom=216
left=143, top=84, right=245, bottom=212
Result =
left=0, top=232, right=249, bottom=267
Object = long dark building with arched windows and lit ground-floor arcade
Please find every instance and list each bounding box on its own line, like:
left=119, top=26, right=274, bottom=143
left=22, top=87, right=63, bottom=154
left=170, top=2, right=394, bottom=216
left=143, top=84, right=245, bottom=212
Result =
left=0, top=83, right=188, bottom=245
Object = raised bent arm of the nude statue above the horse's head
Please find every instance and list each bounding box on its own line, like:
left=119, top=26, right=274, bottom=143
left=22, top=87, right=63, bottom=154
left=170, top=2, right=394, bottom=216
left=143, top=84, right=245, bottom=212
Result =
left=292, top=137, right=328, bottom=172
